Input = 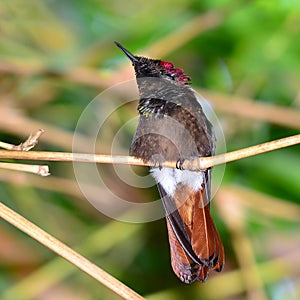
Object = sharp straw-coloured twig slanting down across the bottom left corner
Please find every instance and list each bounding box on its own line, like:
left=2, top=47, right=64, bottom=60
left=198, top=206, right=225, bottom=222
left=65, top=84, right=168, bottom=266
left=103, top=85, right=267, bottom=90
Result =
left=0, top=203, right=144, bottom=300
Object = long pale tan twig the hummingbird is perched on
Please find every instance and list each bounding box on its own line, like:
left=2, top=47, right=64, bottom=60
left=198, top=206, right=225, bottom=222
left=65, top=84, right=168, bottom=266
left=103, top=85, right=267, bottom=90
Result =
left=0, top=134, right=300, bottom=171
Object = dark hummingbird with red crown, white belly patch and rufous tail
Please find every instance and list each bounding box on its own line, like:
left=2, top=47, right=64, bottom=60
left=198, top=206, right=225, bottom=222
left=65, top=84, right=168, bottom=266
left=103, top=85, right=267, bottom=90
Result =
left=115, top=42, right=224, bottom=284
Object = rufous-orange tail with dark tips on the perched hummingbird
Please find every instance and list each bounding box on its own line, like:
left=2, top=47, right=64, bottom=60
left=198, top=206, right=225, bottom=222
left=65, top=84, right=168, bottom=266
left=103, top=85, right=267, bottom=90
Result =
left=157, top=173, right=224, bottom=283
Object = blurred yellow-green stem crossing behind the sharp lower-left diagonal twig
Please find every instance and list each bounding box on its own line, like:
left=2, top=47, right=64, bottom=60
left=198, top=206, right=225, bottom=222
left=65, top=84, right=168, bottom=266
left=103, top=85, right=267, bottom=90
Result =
left=1, top=221, right=144, bottom=300
